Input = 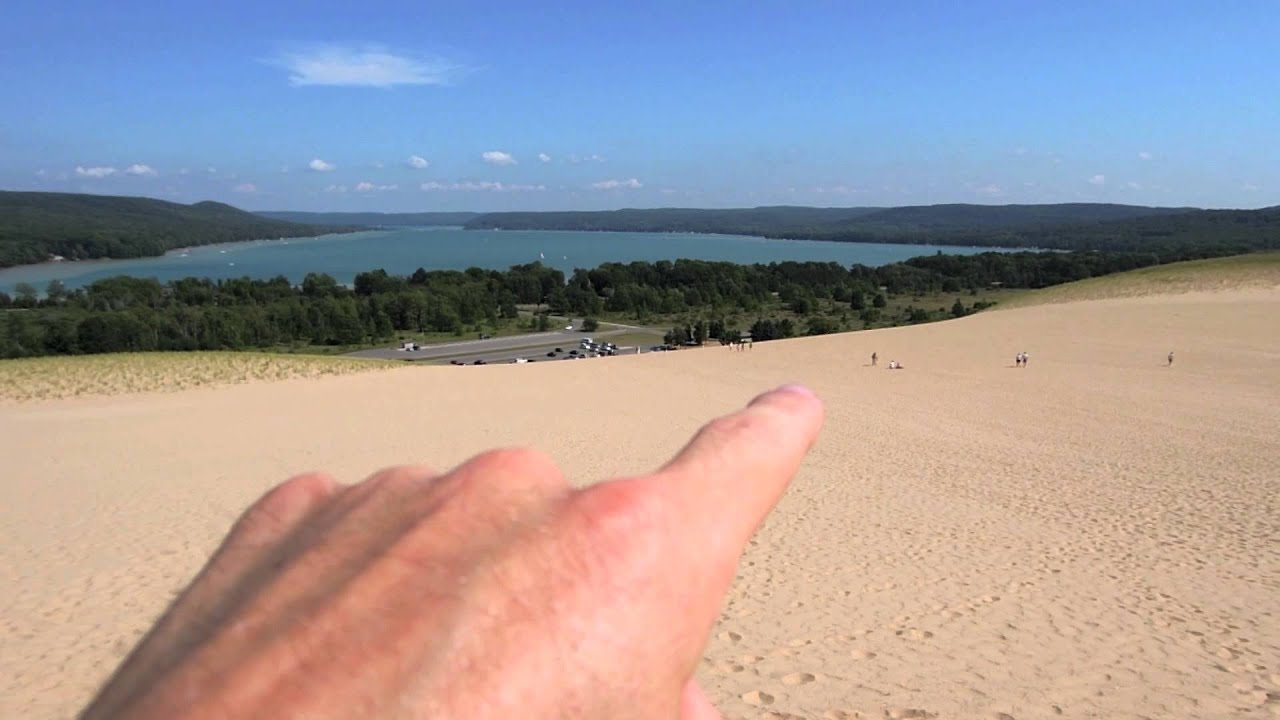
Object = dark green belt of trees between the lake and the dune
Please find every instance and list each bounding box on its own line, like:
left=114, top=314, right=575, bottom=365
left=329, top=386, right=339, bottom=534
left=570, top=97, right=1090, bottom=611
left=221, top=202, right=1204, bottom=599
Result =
left=0, top=249, right=1259, bottom=357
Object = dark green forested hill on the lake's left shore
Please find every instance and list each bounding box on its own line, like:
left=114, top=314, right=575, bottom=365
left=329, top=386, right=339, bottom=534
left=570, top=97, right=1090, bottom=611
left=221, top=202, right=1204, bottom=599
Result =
left=0, top=191, right=361, bottom=268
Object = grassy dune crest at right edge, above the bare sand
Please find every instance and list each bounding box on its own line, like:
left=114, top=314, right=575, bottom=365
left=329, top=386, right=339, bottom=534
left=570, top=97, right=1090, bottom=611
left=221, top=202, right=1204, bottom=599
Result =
left=995, top=252, right=1280, bottom=310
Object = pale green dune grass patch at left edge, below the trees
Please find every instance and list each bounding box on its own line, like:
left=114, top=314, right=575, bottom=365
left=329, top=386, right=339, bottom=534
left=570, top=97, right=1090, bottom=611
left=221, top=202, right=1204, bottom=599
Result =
left=0, top=352, right=401, bottom=402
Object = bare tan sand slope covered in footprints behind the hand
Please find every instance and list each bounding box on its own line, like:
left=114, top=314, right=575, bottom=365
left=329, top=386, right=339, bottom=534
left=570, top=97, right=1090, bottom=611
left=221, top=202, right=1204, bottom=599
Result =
left=0, top=290, right=1280, bottom=720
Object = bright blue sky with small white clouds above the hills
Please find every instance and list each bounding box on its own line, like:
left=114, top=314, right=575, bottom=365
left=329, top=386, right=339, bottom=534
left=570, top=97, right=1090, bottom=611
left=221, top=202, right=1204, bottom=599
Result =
left=0, top=0, right=1280, bottom=211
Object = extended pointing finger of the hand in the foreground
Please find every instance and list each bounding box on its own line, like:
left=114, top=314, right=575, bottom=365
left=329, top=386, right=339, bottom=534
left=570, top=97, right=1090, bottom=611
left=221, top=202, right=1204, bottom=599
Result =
left=645, top=386, right=823, bottom=561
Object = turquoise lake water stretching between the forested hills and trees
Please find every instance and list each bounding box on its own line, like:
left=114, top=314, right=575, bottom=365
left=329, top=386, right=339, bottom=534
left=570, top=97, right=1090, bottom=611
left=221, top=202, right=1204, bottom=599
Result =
left=0, top=228, right=1013, bottom=289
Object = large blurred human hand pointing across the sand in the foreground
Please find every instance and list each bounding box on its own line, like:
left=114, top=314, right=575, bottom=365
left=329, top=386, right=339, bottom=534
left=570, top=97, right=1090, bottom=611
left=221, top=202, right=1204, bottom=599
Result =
left=83, top=387, right=822, bottom=720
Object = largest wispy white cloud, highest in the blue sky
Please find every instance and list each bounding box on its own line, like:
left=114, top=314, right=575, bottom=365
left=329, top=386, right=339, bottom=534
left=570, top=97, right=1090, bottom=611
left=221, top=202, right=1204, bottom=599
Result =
left=268, top=45, right=465, bottom=87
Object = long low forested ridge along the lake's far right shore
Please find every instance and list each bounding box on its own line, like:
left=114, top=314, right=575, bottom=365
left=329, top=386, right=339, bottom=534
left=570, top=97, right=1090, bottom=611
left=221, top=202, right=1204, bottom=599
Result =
left=466, top=204, right=1280, bottom=251
